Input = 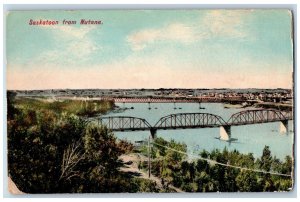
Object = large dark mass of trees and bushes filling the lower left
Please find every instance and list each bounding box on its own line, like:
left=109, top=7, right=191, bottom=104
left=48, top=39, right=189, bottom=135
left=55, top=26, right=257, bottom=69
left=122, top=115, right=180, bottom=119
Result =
left=8, top=95, right=158, bottom=193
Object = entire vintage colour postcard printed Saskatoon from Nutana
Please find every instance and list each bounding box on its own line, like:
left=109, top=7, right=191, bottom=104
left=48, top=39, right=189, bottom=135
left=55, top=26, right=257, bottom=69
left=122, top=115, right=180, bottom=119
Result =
left=6, top=9, right=295, bottom=194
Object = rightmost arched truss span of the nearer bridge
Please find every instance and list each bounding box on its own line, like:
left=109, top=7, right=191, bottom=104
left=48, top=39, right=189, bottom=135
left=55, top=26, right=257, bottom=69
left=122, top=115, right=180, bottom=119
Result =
left=227, top=109, right=292, bottom=125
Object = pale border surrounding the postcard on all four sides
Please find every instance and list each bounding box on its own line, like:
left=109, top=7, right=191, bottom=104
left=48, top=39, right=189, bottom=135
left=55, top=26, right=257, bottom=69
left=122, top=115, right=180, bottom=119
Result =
left=0, top=0, right=299, bottom=201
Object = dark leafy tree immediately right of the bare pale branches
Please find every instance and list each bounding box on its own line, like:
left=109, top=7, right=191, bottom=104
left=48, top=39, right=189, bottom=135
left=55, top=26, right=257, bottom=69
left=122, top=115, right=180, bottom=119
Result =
left=83, top=125, right=122, bottom=192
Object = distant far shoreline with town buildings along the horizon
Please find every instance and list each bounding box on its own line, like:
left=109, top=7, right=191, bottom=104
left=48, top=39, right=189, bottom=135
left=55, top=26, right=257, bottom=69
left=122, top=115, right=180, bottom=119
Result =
left=7, top=88, right=294, bottom=110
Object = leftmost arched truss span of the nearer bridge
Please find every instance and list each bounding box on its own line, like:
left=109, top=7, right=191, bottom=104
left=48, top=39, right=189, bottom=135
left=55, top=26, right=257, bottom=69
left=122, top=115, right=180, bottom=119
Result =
left=97, top=116, right=151, bottom=131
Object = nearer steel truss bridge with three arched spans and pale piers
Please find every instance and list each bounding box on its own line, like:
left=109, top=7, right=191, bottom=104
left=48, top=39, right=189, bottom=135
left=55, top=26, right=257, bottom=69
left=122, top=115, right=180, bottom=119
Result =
left=97, top=109, right=293, bottom=141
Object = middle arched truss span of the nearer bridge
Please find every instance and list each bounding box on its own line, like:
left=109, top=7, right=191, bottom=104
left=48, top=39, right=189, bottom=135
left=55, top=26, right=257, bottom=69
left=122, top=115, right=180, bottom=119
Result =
left=154, top=113, right=227, bottom=129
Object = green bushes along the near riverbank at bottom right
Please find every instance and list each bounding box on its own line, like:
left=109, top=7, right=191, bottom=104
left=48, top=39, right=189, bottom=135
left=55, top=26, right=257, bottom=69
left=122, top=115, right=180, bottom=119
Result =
left=139, top=138, right=293, bottom=192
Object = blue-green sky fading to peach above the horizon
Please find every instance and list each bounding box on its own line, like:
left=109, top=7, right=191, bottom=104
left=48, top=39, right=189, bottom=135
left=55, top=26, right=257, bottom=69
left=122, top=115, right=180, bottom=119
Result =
left=6, top=9, right=293, bottom=90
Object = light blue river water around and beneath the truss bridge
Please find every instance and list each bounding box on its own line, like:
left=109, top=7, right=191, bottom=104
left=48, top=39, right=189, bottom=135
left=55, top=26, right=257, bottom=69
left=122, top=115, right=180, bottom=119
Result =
left=101, top=103, right=293, bottom=160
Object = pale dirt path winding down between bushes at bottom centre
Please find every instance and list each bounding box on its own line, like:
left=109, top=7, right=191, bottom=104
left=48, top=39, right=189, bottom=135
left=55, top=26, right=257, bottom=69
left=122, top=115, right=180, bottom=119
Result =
left=120, top=154, right=183, bottom=192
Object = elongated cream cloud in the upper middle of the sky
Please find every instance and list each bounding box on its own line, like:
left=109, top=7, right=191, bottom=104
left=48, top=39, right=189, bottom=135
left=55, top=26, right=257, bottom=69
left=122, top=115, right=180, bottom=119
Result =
left=127, top=23, right=196, bottom=50
